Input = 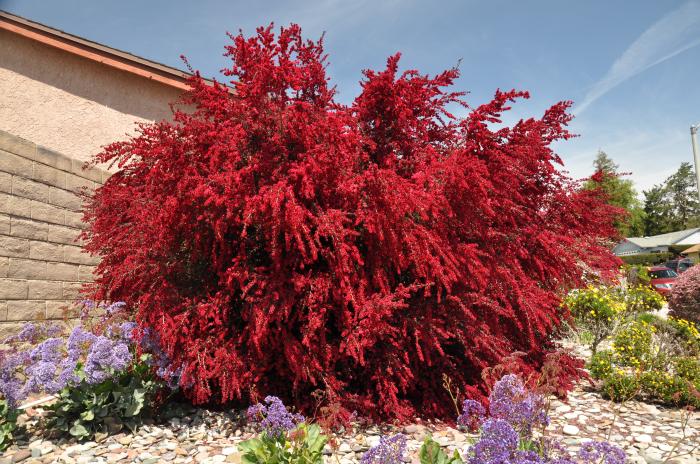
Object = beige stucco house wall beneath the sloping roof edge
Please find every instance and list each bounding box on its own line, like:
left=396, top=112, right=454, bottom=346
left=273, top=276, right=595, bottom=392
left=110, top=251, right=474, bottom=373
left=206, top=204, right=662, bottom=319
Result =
left=0, top=30, right=180, bottom=161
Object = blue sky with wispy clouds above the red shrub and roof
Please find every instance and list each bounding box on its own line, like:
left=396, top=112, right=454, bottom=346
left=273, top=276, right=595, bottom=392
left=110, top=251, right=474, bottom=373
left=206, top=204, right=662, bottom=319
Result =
left=0, top=0, right=700, bottom=190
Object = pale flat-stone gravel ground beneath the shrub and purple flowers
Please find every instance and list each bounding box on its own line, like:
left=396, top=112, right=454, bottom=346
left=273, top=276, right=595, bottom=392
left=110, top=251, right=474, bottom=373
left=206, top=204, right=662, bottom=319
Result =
left=0, top=389, right=700, bottom=464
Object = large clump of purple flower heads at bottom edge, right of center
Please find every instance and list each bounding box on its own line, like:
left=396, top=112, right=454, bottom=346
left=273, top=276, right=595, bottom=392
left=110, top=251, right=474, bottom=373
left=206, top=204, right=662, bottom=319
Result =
left=458, top=374, right=625, bottom=464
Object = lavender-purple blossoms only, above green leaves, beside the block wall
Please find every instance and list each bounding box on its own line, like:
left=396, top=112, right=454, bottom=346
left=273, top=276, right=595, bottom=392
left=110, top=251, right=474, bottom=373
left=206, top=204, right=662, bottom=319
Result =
left=0, top=301, right=177, bottom=408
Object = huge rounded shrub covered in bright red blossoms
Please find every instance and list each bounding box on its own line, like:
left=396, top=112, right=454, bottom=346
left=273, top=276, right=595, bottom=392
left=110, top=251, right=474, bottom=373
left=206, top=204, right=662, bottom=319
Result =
left=79, top=26, right=617, bottom=419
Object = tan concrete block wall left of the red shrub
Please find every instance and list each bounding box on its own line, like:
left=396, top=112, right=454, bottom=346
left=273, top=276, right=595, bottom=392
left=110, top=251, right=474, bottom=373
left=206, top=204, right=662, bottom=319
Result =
left=0, top=131, right=109, bottom=339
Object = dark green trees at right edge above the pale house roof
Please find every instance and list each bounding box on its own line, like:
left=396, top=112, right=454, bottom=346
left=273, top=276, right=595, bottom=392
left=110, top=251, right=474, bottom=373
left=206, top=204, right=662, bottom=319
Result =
left=644, top=162, right=700, bottom=235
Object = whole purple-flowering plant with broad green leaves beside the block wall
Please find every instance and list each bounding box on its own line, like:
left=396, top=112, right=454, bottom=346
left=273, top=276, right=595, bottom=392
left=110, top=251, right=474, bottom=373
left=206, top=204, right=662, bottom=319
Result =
left=0, top=301, right=174, bottom=439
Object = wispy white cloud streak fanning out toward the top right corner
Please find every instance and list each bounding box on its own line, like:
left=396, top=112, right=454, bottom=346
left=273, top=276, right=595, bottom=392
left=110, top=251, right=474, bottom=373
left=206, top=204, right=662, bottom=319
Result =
left=573, top=1, right=700, bottom=115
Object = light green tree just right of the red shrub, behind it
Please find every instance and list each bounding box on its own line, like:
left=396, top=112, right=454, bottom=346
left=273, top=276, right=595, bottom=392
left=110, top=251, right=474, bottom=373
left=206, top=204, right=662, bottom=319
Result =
left=584, top=150, right=645, bottom=237
